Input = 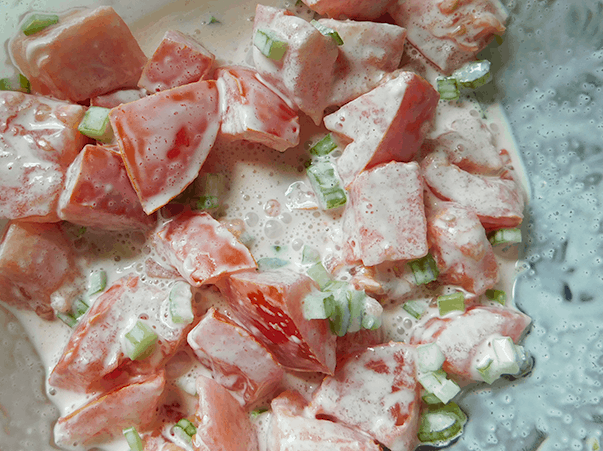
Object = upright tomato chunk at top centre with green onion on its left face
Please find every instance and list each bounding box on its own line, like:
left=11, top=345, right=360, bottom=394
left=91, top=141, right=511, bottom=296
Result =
left=253, top=5, right=338, bottom=125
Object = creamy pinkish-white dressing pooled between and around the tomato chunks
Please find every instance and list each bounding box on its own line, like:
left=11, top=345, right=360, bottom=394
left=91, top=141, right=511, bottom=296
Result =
left=0, top=1, right=527, bottom=451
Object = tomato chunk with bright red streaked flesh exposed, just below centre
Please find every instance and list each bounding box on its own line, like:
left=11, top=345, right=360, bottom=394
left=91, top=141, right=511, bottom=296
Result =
left=218, top=269, right=335, bottom=374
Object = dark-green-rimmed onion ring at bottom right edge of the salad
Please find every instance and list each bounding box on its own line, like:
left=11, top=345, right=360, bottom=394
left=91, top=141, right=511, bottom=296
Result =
left=417, top=402, right=467, bottom=446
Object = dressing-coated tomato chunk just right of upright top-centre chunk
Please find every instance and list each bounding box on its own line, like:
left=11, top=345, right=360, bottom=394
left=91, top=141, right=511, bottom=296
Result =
left=318, top=20, right=406, bottom=105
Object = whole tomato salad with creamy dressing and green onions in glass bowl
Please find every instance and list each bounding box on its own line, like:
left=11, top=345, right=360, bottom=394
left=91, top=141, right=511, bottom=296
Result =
left=0, top=0, right=531, bottom=451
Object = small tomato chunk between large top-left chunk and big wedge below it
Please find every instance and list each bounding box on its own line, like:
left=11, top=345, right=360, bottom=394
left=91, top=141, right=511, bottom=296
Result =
left=138, top=30, right=215, bottom=92
